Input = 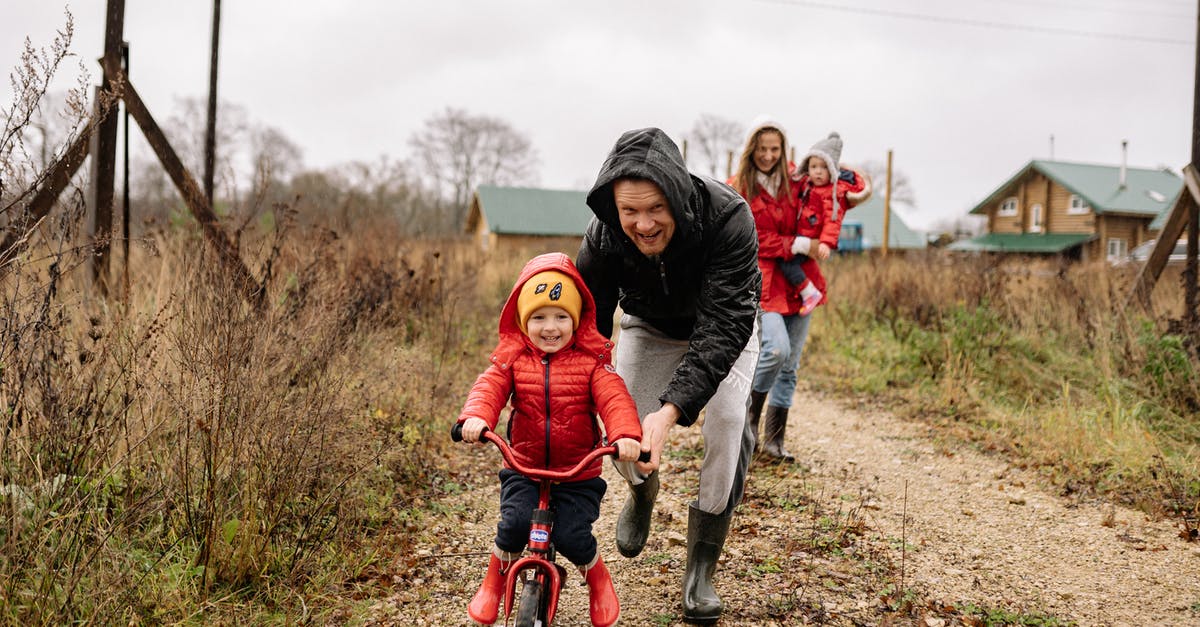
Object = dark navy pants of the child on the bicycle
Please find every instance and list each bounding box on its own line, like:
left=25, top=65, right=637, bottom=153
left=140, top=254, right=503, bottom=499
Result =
left=496, top=468, right=608, bottom=566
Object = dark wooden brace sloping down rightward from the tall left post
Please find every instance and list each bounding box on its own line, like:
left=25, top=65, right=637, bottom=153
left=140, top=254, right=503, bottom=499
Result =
left=107, top=66, right=262, bottom=306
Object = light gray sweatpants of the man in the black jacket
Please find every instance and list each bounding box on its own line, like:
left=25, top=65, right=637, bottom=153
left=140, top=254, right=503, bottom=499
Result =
left=613, top=314, right=758, bottom=514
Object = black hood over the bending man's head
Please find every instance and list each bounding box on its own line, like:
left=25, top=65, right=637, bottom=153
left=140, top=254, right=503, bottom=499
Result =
left=588, top=127, right=696, bottom=253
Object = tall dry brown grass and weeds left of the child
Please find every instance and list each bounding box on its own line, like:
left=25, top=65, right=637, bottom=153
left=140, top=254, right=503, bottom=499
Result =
left=0, top=194, right=535, bottom=623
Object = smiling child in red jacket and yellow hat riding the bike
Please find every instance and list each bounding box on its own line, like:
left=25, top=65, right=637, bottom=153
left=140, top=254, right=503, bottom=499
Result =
left=458, top=252, right=642, bottom=627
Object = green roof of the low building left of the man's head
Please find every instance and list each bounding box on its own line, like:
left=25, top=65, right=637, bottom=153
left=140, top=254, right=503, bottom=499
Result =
left=475, top=185, right=592, bottom=235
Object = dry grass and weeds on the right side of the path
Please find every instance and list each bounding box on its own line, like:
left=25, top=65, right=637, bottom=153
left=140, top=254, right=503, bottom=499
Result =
left=802, top=252, right=1200, bottom=515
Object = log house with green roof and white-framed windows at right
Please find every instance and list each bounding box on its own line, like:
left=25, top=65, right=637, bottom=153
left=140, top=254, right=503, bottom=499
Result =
left=949, top=160, right=1183, bottom=261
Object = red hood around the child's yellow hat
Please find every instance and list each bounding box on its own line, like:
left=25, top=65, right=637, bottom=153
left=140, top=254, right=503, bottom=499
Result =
left=492, top=252, right=612, bottom=368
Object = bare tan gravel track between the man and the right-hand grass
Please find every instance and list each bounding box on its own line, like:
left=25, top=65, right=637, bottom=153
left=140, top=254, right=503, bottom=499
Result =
left=788, top=386, right=1200, bottom=626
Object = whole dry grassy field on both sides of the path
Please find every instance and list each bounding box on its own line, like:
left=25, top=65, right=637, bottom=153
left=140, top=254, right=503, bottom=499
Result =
left=0, top=228, right=1200, bottom=625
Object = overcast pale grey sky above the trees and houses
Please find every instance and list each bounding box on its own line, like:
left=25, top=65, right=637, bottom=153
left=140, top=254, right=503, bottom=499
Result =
left=0, top=0, right=1196, bottom=228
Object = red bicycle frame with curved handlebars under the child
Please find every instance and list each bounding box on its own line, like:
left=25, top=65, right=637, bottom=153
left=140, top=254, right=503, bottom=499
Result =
left=450, top=423, right=649, bottom=626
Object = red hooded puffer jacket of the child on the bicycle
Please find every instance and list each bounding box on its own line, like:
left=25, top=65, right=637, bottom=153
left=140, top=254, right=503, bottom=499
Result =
left=458, top=252, right=642, bottom=480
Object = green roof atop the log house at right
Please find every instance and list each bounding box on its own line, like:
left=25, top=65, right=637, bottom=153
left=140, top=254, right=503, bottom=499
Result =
left=971, top=160, right=1183, bottom=216
